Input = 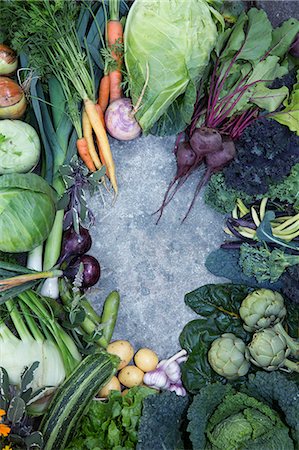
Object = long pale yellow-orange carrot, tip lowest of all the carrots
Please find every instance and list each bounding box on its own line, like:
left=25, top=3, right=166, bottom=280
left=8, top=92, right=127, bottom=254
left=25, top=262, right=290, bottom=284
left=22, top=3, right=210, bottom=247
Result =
left=84, top=98, right=118, bottom=195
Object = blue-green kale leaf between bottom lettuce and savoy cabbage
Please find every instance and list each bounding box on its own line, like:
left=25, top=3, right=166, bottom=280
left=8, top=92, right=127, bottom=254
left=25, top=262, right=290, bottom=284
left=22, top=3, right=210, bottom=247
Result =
left=136, top=391, right=189, bottom=450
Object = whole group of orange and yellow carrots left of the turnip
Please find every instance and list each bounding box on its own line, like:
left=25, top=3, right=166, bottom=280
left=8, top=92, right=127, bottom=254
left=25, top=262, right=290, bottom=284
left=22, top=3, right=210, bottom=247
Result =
left=77, top=0, right=123, bottom=193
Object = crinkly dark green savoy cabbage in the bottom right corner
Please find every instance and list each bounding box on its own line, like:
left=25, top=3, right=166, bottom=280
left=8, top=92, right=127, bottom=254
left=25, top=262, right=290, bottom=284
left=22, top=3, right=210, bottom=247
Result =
left=188, top=384, right=294, bottom=450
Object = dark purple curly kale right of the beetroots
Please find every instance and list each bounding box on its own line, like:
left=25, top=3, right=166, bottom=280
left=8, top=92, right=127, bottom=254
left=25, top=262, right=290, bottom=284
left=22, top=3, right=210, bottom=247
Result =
left=223, top=118, right=299, bottom=196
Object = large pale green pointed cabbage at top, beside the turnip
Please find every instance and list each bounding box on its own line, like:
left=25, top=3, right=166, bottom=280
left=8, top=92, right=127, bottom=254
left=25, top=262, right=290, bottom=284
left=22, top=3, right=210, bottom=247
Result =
left=124, top=0, right=223, bottom=135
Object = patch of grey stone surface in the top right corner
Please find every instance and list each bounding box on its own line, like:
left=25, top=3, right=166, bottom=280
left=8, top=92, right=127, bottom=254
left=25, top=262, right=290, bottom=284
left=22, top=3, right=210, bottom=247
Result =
left=255, top=0, right=299, bottom=26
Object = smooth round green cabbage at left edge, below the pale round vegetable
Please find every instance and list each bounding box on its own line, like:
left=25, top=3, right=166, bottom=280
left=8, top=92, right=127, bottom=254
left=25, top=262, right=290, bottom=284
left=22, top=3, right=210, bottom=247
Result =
left=0, top=173, right=56, bottom=253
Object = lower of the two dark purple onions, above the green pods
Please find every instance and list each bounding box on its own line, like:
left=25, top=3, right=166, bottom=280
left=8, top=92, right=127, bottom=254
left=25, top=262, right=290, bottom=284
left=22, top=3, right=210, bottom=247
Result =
left=64, top=255, right=101, bottom=288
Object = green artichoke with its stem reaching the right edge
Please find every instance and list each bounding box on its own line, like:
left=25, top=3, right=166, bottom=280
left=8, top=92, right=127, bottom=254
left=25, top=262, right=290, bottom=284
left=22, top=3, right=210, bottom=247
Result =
left=248, top=328, right=299, bottom=372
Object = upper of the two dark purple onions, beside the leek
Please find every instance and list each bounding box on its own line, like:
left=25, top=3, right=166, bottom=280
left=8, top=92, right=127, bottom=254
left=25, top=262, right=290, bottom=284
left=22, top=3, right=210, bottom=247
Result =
left=59, top=226, right=92, bottom=264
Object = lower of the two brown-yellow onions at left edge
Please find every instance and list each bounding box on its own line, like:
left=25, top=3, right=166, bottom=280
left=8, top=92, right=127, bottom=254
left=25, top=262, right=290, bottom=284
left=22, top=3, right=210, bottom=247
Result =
left=0, top=77, right=27, bottom=119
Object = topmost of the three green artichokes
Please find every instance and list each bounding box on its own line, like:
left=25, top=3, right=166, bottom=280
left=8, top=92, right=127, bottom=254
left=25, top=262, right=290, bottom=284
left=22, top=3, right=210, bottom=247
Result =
left=240, top=289, right=287, bottom=332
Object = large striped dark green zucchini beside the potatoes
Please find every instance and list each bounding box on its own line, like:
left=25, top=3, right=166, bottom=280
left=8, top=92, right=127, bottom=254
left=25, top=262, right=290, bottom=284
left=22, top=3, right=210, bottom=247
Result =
left=39, top=352, right=119, bottom=450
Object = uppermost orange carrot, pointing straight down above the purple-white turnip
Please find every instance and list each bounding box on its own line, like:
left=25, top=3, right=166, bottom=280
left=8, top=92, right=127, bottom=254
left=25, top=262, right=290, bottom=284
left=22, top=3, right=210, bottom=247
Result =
left=107, top=16, right=123, bottom=103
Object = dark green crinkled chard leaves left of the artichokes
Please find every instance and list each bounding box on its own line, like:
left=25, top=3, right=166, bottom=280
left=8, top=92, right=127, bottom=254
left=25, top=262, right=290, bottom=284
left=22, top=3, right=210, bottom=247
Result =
left=180, top=284, right=250, bottom=393
